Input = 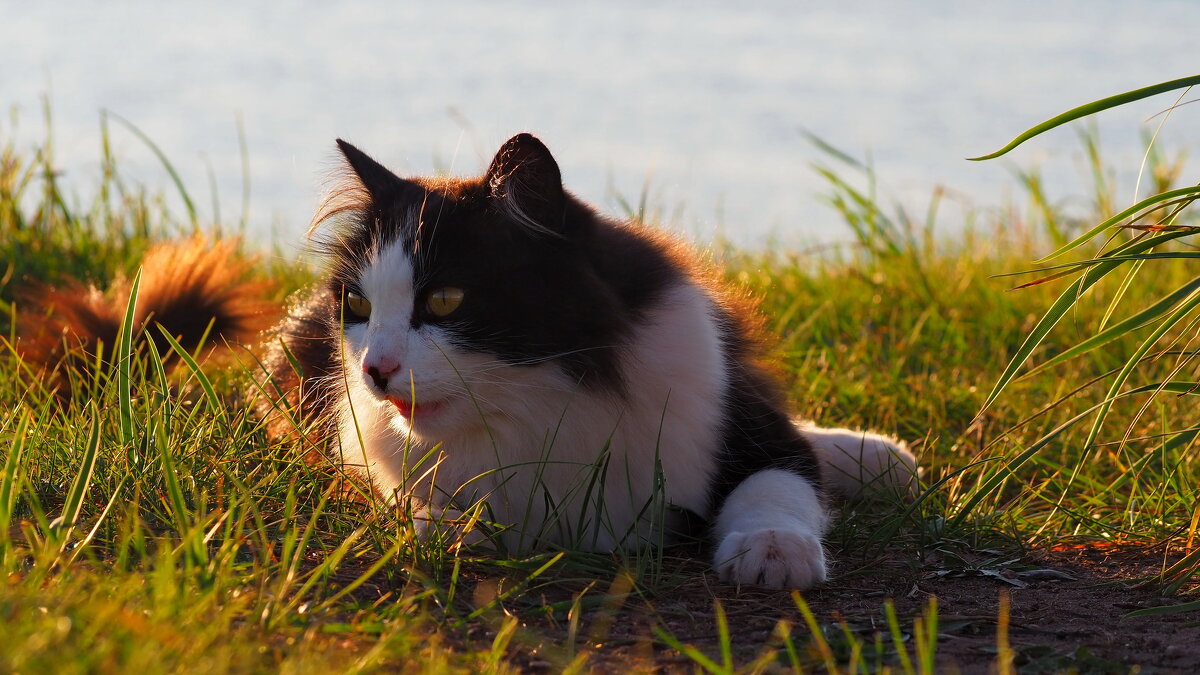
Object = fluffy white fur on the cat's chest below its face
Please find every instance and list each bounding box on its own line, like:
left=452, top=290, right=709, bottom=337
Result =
left=338, top=278, right=726, bottom=550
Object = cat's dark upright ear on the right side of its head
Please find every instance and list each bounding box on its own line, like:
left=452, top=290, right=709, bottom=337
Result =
left=485, top=133, right=566, bottom=235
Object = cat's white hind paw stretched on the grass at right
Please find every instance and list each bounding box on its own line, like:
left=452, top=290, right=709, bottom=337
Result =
left=796, top=422, right=920, bottom=500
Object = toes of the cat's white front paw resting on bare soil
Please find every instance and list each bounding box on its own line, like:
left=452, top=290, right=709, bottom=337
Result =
left=713, top=530, right=826, bottom=591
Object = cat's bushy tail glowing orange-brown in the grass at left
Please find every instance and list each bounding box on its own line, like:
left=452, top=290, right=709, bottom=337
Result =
left=16, top=235, right=278, bottom=386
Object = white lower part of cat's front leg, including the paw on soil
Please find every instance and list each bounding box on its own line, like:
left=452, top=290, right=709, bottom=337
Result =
left=713, top=468, right=828, bottom=590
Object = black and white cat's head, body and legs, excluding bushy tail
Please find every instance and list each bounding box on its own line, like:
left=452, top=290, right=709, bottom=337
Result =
left=266, top=133, right=916, bottom=589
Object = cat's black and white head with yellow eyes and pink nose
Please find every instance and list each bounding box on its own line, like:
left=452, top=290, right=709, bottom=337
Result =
left=318, top=133, right=630, bottom=438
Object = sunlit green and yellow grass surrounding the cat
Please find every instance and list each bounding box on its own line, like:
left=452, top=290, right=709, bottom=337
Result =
left=0, top=85, right=1200, bottom=673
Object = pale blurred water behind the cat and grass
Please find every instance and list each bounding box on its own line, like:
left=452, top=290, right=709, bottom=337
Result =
left=0, top=0, right=1200, bottom=245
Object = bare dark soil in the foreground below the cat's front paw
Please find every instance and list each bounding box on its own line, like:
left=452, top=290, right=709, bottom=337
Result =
left=472, top=545, right=1200, bottom=674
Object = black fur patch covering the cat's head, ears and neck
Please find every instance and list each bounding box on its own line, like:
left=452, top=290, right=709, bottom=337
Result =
left=309, top=135, right=682, bottom=392
